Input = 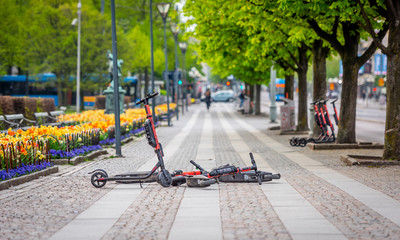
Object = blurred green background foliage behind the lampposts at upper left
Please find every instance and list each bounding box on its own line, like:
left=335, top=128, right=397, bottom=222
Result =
left=0, top=0, right=180, bottom=102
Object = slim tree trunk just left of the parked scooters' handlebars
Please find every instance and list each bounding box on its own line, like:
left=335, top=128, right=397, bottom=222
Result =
left=296, top=46, right=308, bottom=131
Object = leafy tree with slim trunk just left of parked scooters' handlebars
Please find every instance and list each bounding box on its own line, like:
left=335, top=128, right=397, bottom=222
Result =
left=230, top=1, right=315, bottom=131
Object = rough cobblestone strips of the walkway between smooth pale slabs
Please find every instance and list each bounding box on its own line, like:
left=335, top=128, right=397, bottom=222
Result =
left=0, top=103, right=400, bottom=239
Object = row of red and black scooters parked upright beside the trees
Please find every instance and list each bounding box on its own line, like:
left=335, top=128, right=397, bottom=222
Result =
left=289, top=98, right=339, bottom=147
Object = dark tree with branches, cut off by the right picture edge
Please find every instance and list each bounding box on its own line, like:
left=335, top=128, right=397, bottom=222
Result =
left=356, top=0, right=400, bottom=160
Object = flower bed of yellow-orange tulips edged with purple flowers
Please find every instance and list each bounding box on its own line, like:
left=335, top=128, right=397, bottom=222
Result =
left=0, top=104, right=176, bottom=181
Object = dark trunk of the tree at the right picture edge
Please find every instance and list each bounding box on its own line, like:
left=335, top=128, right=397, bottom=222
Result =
left=382, top=10, right=400, bottom=160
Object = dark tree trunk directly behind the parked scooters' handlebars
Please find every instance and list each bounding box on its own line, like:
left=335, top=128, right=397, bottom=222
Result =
left=312, top=40, right=329, bottom=136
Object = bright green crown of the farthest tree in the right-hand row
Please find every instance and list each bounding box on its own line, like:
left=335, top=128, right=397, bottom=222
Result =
left=184, top=0, right=271, bottom=114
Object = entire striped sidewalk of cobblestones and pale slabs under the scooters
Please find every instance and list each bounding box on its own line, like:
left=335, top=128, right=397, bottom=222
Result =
left=0, top=103, right=400, bottom=240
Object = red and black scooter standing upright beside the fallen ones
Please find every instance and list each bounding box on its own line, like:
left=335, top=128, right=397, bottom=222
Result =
left=89, top=92, right=172, bottom=188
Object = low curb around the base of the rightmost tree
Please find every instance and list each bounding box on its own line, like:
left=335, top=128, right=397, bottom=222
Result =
left=340, top=155, right=400, bottom=166
